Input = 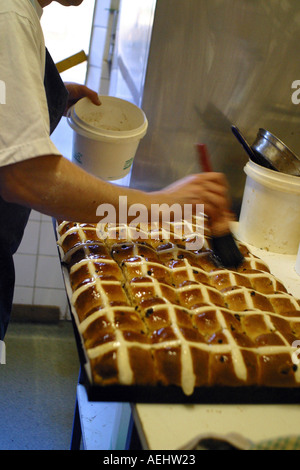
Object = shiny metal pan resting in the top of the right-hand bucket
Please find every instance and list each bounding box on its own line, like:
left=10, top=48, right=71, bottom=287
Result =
left=251, top=129, right=300, bottom=176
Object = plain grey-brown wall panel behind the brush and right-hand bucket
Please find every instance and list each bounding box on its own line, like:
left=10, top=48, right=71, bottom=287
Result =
left=131, top=0, right=300, bottom=212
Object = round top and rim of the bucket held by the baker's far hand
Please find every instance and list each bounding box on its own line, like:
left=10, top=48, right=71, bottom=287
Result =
left=67, top=96, right=148, bottom=142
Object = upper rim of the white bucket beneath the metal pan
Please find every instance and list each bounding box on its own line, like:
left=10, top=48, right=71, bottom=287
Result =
left=244, top=160, right=300, bottom=194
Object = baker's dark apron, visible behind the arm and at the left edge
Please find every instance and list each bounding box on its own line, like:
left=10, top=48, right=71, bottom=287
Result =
left=0, top=49, right=68, bottom=340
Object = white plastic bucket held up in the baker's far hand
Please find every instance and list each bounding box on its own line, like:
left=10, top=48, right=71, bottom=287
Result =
left=67, top=96, right=148, bottom=180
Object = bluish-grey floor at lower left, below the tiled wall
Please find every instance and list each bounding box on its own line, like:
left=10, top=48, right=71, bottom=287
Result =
left=0, top=321, right=79, bottom=450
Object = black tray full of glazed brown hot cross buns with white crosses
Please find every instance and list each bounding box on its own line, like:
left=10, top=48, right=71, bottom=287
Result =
left=55, top=217, right=300, bottom=403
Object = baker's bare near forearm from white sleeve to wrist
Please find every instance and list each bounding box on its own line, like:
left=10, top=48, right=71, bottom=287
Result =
left=0, top=155, right=150, bottom=223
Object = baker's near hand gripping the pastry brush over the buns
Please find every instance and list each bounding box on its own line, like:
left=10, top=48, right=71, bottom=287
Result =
left=152, top=172, right=230, bottom=221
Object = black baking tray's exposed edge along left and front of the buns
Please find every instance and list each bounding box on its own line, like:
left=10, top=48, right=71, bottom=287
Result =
left=53, top=219, right=300, bottom=405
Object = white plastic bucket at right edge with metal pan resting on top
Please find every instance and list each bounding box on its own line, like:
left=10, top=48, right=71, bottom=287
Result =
left=238, top=161, right=300, bottom=254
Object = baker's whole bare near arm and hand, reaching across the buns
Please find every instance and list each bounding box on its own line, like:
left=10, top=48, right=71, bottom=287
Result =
left=0, top=155, right=228, bottom=223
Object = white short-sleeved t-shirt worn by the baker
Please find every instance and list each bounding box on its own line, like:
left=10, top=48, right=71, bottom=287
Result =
left=0, top=0, right=60, bottom=166
